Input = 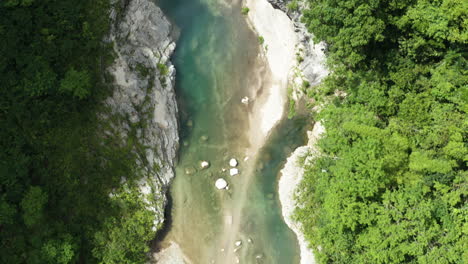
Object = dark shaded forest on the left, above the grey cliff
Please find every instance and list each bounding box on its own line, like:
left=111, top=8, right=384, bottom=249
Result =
left=0, top=0, right=159, bottom=263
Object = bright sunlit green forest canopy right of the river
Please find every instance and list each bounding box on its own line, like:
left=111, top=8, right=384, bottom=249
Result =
left=297, top=0, right=468, bottom=264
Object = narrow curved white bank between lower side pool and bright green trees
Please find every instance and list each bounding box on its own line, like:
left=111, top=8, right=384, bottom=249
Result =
left=279, top=122, right=325, bottom=264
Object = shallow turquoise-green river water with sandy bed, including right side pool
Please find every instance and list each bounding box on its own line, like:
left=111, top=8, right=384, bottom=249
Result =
left=157, top=0, right=305, bottom=264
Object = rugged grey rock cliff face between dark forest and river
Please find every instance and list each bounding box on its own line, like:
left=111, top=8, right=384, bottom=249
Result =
left=106, top=0, right=179, bottom=230
